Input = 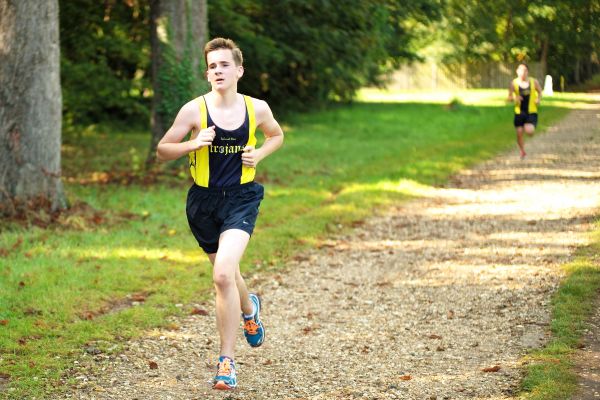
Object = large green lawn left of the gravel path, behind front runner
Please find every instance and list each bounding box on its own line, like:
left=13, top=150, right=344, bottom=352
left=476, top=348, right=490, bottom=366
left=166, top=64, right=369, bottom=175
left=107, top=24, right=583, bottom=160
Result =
left=0, top=91, right=584, bottom=399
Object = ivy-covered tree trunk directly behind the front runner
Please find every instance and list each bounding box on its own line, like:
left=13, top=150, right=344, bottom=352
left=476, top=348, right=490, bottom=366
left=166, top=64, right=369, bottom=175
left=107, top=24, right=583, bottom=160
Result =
left=146, top=0, right=207, bottom=166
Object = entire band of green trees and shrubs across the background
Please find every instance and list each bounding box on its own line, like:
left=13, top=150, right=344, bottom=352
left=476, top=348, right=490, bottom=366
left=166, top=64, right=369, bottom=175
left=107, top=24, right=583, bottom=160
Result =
left=60, top=0, right=600, bottom=126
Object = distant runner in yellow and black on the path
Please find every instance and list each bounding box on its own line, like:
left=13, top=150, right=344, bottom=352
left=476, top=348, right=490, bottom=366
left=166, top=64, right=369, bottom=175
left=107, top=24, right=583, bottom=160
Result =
left=508, top=63, right=542, bottom=159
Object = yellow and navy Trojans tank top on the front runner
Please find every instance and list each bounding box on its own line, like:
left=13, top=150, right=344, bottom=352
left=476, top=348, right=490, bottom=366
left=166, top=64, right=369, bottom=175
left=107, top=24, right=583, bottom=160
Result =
left=189, top=96, right=256, bottom=188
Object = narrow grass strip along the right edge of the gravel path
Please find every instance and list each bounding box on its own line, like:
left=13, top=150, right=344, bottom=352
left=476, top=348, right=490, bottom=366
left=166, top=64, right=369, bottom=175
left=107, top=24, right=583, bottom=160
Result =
left=521, top=221, right=600, bottom=400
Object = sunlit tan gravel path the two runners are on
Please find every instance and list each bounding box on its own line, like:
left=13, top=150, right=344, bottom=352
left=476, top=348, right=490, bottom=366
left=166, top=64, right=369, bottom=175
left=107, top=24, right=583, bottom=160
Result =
left=66, top=104, right=600, bottom=400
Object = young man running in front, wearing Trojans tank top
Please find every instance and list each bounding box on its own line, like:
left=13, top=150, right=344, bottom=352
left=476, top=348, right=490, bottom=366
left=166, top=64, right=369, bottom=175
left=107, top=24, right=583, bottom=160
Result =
left=156, top=38, right=283, bottom=390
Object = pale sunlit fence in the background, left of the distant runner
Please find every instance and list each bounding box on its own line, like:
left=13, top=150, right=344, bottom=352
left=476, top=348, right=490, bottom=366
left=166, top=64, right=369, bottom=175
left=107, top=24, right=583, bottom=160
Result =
left=388, top=62, right=544, bottom=90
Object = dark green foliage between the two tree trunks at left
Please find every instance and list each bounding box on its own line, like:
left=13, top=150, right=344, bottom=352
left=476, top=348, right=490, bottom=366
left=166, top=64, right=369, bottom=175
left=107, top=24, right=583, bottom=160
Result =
left=60, top=0, right=151, bottom=125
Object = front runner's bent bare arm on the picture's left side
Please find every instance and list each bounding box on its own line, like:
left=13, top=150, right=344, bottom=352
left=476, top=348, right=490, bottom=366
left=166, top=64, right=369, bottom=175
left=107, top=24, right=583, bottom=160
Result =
left=156, top=100, right=215, bottom=161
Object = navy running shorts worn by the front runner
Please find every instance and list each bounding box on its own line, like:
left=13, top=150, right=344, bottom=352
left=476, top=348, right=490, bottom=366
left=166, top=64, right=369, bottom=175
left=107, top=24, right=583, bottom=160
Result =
left=185, top=182, right=264, bottom=254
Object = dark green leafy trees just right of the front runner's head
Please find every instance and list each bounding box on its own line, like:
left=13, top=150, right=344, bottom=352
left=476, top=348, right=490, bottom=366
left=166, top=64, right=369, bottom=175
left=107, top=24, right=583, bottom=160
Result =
left=209, top=0, right=437, bottom=108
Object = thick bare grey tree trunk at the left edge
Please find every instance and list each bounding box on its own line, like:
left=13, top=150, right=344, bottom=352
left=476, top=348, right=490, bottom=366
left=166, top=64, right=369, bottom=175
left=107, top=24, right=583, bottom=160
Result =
left=0, top=0, right=66, bottom=213
